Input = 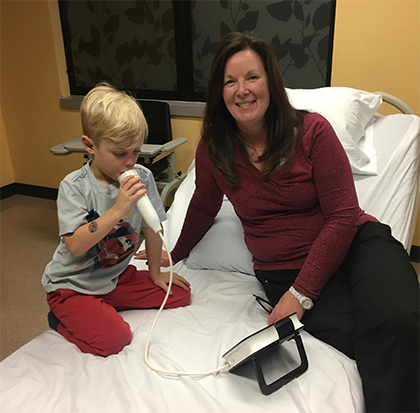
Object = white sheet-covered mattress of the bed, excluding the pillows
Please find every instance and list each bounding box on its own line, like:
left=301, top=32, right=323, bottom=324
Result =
left=0, top=115, right=419, bottom=413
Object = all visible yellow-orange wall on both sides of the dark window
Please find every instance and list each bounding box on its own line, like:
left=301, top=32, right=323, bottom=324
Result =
left=0, top=0, right=420, bottom=241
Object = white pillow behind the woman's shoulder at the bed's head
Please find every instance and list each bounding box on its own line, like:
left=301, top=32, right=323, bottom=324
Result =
left=286, top=87, right=382, bottom=175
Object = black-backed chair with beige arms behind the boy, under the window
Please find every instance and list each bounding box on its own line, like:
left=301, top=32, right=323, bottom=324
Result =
left=50, top=100, right=188, bottom=207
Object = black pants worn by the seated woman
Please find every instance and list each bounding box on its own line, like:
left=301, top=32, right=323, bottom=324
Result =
left=255, top=222, right=420, bottom=413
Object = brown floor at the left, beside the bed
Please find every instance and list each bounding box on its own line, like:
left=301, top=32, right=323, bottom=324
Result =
left=0, top=195, right=59, bottom=360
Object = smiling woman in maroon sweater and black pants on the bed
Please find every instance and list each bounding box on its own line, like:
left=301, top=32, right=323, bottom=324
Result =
left=138, top=33, right=420, bottom=413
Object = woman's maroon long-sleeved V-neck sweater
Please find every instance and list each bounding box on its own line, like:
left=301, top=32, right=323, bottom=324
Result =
left=172, top=113, right=376, bottom=299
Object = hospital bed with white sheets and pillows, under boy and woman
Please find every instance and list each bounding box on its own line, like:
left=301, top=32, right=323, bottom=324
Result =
left=0, top=88, right=420, bottom=413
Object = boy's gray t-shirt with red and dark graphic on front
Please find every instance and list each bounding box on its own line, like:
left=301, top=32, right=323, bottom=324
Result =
left=42, top=164, right=166, bottom=295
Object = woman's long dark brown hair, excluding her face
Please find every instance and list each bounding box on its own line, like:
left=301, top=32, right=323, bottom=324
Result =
left=202, top=33, right=306, bottom=186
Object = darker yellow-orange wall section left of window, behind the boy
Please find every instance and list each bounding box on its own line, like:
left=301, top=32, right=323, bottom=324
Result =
left=0, top=0, right=80, bottom=187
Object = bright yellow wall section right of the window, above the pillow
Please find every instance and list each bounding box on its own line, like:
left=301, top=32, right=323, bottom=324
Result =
left=332, top=0, right=420, bottom=114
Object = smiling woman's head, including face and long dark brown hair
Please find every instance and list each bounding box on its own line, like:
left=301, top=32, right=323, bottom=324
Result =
left=202, top=33, right=306, bottom=184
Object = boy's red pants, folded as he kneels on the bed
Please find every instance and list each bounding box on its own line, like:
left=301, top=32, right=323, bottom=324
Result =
left=47, top=265, right=191, bottom=357
